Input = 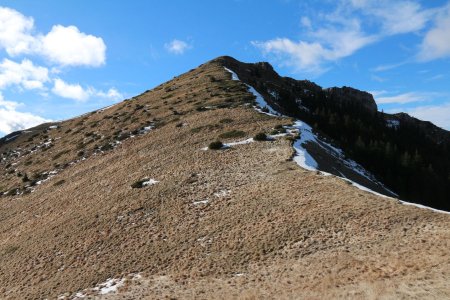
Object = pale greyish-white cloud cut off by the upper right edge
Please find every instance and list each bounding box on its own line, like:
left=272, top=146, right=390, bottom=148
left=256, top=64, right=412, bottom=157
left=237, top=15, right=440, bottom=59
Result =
left=418, top=5, right=450, bottom=61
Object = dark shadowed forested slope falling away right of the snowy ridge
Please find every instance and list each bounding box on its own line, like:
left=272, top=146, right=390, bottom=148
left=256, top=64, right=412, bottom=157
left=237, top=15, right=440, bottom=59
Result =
left=217, top=57, right=450, bottom=211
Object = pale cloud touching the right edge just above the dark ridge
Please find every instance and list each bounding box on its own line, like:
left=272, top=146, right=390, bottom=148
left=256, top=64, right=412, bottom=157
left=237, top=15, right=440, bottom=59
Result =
left=396, top=103, right=450, bottom=130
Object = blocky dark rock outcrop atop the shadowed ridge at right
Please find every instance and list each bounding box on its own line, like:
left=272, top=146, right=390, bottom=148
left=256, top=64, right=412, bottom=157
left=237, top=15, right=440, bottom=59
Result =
left=325, top=86, right=378, bottom=112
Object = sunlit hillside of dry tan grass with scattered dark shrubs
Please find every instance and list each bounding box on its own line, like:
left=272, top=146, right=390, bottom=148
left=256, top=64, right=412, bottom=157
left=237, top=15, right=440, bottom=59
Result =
left=0, top=58, right=450, bottom=299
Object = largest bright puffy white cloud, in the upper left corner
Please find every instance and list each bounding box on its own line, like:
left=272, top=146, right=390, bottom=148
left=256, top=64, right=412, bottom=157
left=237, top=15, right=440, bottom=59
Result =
left=0, top=7, right=106, bottom=67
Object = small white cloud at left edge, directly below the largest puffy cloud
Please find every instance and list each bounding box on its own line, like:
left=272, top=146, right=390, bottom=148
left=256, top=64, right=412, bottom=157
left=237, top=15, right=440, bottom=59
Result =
left=0, top=58, right=49, bottom=90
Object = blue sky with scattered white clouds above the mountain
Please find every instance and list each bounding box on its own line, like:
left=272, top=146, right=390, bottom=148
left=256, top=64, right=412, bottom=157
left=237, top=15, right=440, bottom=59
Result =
left=0, top=0, right=450, bottom=136
